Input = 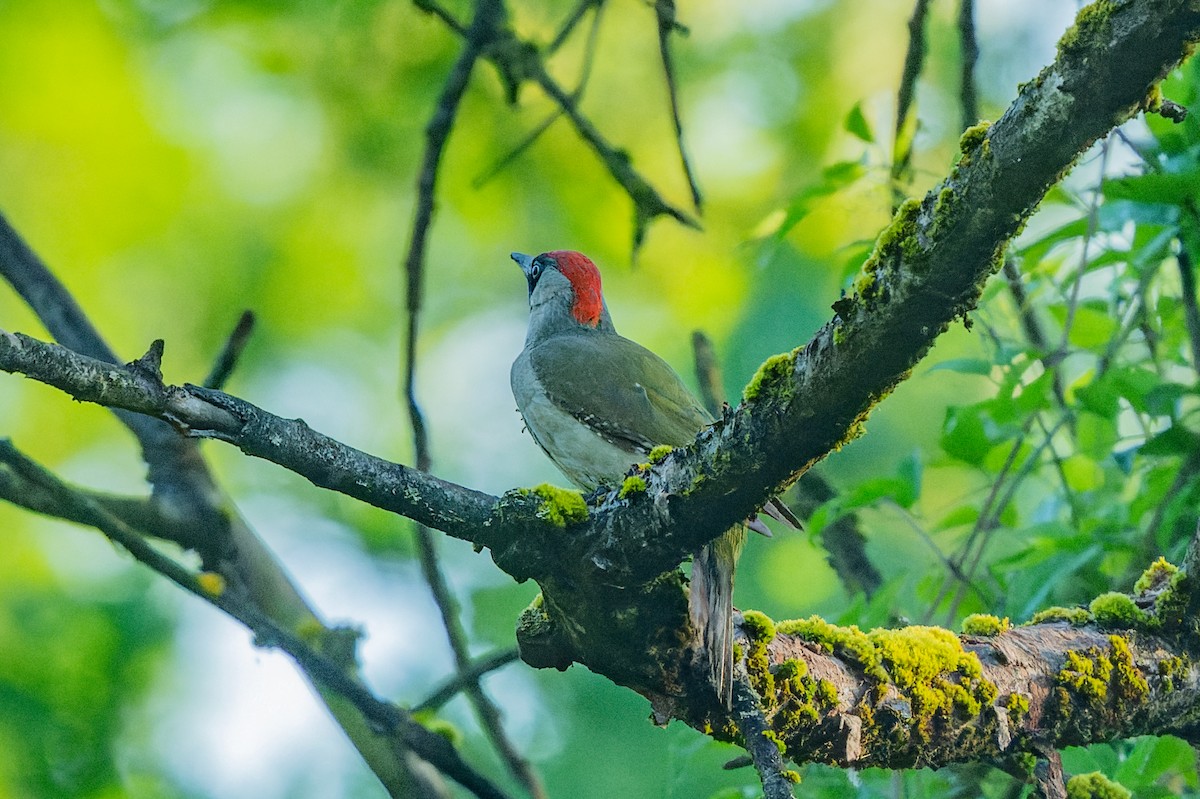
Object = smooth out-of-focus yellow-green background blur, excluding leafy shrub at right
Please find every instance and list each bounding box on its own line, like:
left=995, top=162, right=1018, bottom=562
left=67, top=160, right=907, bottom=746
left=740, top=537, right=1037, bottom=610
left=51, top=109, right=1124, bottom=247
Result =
left=0, top=0, right=1195, bottom=799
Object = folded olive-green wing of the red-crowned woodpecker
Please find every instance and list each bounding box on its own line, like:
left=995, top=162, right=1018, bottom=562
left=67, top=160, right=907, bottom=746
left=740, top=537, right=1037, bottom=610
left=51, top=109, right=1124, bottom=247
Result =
left=528, top=332, right=712, bottom=450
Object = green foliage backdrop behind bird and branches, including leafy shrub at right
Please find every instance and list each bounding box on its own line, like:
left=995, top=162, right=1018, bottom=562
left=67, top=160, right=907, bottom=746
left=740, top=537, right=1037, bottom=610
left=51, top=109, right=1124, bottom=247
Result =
left=0, top=0, right=1200, bottom=798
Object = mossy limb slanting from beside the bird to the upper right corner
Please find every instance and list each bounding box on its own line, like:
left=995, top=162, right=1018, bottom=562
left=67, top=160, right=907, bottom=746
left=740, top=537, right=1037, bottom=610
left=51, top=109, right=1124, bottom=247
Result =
left=561, top=0, right=1200, bottom=578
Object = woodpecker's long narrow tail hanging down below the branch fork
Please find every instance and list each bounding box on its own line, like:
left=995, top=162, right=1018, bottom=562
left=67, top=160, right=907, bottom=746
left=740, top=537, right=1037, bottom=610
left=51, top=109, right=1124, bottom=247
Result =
left=689, top=524, right=746, bottom=708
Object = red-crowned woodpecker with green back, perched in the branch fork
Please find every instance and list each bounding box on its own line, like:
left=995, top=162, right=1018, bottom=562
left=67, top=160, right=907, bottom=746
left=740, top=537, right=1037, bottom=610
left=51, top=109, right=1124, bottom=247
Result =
left=511, top=250, right=799, bottom=707
